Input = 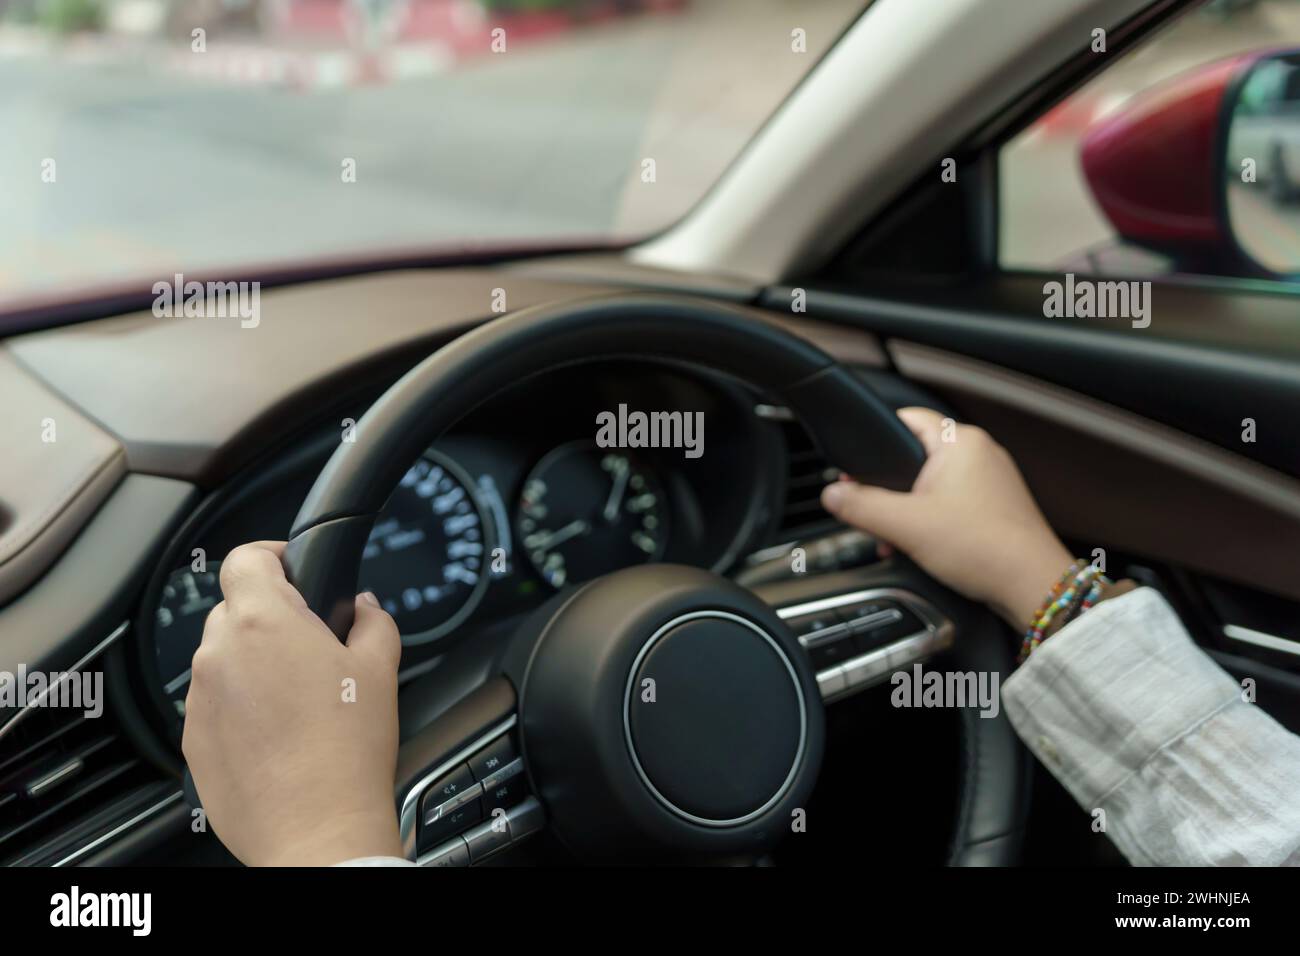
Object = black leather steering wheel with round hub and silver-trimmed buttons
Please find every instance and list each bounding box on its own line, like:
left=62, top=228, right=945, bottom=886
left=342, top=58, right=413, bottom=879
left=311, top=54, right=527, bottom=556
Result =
left=271, top=295, right=1027, bottom=865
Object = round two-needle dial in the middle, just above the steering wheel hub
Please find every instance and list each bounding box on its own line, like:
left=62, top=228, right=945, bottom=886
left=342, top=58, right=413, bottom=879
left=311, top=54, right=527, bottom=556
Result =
left=519, top=441, right=668, bottom=588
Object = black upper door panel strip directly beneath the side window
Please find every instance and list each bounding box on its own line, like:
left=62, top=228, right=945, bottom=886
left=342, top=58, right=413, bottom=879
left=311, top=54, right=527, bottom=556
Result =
left=762, top=282, right=1300, bottom=479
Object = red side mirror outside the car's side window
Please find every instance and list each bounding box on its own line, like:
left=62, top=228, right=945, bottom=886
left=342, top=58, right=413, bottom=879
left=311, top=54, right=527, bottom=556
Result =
left=1080, top=51, right=1300, bottom=278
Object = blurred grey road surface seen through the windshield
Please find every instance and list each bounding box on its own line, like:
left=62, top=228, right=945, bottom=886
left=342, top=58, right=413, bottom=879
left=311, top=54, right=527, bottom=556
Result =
left=0, top=0, right=857, bottom=300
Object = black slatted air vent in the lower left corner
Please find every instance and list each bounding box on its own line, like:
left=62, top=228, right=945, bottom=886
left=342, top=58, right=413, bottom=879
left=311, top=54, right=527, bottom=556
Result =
left=0, top=691, right=147, bottom=864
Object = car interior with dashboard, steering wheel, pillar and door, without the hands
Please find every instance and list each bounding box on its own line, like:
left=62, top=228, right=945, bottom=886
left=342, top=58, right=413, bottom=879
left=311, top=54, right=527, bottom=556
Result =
left=0, top=0, right=1300, bottom=866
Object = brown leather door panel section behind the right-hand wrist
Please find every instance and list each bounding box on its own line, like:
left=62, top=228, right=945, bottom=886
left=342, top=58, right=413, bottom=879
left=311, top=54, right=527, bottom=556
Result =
left=888, top=341, right=1300, bottom=600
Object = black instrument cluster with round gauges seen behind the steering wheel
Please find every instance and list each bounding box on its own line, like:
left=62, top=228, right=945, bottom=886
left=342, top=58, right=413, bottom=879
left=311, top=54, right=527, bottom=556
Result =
left=138, top=362, right=787, bottom=730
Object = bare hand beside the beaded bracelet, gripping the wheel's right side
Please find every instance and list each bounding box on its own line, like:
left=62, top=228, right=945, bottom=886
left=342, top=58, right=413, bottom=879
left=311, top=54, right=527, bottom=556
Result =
left=822, top=408, right=1073, bottom=631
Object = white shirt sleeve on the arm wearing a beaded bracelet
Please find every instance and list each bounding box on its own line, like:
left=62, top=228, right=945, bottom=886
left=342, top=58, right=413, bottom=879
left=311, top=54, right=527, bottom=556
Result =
left=1002, top=588, right=1300, bottom=866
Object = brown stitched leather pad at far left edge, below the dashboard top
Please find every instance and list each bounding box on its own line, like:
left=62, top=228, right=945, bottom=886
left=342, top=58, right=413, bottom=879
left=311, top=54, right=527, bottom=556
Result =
left=0, top=347, right=126, bottom=604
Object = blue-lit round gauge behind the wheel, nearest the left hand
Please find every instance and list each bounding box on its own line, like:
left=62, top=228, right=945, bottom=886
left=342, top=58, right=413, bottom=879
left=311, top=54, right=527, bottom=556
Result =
left=359, top=451, right=494, bottom=644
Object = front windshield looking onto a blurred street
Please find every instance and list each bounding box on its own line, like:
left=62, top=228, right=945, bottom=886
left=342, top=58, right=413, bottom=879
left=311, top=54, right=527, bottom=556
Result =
left=0, top=0, right=863, bottom=304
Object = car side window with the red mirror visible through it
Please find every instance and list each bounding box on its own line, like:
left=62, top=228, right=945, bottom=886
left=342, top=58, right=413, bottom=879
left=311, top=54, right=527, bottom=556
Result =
left=998, top=0, right=1300, bottom=284
